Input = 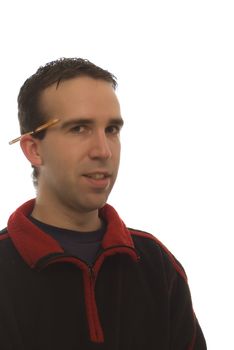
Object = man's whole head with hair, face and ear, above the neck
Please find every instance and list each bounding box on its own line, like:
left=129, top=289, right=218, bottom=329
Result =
left=18, top=59, right=122, bottom=211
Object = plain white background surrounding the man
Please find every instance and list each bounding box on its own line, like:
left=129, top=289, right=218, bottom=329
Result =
left=0, top=0, right=234, bottom=350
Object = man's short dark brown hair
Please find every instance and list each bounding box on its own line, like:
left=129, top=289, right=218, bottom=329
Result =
left=18, top=57, right=117, bottom=186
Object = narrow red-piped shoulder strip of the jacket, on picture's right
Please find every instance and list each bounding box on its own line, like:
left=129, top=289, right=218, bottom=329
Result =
left=128, top=228, right=187, bottom=283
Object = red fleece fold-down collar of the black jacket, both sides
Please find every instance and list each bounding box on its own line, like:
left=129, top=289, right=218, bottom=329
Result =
left=7, top=199, right=134, bottom=267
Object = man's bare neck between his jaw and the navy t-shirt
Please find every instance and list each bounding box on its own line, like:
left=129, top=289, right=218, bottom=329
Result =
left=31, top=198, right=101, bottom=232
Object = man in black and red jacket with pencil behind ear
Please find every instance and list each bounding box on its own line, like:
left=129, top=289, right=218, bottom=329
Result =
left=0, top=58, right=206, bottom=350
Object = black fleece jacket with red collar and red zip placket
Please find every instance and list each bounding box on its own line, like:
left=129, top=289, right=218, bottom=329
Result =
left=0, top=200, right=206, bottom=350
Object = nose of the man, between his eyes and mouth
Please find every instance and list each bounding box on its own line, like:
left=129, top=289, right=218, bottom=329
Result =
left=89, top=132, right=112, bottom=160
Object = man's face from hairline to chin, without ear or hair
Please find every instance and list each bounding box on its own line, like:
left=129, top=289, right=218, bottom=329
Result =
left=35, top=77, right=122, bottom=212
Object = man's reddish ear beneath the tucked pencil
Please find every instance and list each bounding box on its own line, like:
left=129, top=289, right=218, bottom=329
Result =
left=20, top=135, right=42, bottom=167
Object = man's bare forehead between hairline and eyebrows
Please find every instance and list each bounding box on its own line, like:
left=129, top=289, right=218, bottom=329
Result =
left=39, top=77, right=120, bottom=119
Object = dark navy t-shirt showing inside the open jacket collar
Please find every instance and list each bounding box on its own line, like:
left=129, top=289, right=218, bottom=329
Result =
left=29, top=216, right=106, bottom=265
